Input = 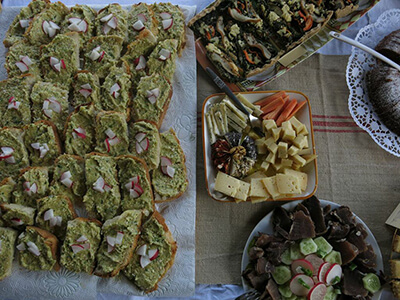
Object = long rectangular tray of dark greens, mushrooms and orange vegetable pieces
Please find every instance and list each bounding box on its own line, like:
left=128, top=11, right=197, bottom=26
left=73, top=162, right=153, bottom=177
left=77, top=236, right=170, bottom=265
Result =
left=188, top=0, right=379, bottom=90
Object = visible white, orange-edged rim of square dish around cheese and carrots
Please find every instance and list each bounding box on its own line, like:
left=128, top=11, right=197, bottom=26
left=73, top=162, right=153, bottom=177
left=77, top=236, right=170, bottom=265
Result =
left=202, top=91, right=318, bottom=202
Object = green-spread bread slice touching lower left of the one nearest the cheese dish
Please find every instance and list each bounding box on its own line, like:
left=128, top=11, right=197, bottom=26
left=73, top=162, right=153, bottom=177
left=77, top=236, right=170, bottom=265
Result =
left=116, top=155, right=154, bottom=216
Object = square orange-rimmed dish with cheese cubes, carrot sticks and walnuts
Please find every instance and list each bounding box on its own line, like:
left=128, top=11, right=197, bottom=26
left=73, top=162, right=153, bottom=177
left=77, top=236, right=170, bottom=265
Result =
left=202, top=91, right=318, bottom=203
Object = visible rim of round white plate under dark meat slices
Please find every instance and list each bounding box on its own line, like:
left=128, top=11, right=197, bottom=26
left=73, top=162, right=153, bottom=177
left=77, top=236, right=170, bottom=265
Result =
left=241, top=200, right=383, bottom=300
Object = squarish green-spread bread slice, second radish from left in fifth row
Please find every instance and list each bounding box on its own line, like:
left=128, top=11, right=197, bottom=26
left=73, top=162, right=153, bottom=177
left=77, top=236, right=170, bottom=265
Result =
left=50, top=154, right=86, bottom=203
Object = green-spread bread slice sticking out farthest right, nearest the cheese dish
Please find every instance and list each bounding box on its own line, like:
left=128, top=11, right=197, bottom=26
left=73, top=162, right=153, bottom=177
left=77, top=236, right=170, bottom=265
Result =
left=152, top=128, right=188, bottom=202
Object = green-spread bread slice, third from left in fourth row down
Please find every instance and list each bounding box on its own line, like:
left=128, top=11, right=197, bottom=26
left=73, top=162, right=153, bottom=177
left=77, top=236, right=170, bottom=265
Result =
left=64, top=104, right=96, bottom=157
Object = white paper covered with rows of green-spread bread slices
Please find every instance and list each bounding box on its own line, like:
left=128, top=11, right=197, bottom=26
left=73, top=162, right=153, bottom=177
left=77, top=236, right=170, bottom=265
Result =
left=0, top=0, right=196, bottom=299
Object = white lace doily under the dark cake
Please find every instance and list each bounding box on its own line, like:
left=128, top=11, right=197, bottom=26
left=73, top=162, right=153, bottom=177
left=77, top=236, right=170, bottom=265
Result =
left=346, top=9, right=400, bottom=157
